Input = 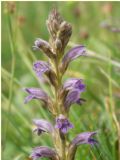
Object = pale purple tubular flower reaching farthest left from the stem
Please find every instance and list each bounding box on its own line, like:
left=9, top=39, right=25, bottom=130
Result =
left=24, top=88, right=50, bottom=103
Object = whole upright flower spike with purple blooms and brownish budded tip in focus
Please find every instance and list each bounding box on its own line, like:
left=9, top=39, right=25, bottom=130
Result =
left=25, top=9, right=97, bottom=160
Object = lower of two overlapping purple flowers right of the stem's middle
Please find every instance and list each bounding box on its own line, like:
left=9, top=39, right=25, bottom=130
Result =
left=64, top=89, right=81, bottom=110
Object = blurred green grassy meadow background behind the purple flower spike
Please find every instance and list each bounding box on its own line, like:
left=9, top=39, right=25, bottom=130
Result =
left=1, top=1, right=120, bottom=160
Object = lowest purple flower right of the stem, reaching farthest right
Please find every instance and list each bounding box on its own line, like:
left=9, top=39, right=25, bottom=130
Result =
left=71, top=132, right=97, bottom=146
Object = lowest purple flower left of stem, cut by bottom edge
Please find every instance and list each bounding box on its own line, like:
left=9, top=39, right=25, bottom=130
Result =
left=30, top=146, right=59, bottom=160
